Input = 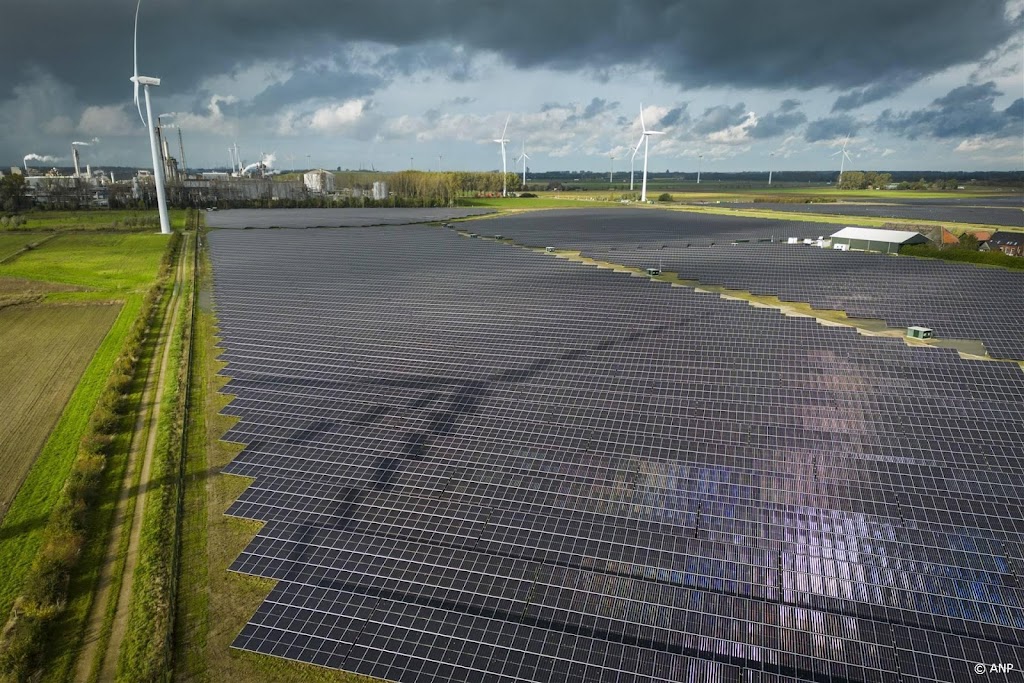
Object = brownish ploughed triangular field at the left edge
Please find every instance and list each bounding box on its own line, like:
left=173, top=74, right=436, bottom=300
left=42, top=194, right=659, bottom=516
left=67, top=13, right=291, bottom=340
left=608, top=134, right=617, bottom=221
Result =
left=0, top=304, right=121, bottom=519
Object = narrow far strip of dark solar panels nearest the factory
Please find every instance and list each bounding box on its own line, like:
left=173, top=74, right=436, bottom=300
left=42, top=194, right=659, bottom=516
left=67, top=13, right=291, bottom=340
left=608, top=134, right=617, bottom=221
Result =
left=206, top=208, right=492, bottom=228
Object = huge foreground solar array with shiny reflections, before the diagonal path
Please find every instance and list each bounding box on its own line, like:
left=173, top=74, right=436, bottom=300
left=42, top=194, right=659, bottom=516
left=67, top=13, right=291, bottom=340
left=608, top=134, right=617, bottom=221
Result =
left=210, top=227, right=1024, bottom=683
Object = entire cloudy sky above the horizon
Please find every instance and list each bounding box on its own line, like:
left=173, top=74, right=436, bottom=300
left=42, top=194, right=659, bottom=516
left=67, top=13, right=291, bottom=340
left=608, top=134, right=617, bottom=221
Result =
left=0, top=0, right=1024, bottom=172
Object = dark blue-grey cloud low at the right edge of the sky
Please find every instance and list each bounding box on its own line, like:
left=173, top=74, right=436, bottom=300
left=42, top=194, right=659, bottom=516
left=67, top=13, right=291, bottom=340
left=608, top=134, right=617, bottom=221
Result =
left=874, top=81, right=1024, bottom=140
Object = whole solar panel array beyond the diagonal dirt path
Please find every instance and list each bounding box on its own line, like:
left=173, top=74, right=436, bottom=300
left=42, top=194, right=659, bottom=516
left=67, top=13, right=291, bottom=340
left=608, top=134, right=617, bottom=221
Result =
left=475, top=211, right=1024, bottom=359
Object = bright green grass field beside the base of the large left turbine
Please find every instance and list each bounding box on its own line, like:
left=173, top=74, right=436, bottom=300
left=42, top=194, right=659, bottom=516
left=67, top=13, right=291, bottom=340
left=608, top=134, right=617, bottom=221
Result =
left=0, top=232, right=168, bottom=301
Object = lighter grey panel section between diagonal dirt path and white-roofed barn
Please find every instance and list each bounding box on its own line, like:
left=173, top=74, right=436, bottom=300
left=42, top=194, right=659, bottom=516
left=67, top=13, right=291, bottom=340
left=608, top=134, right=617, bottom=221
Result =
left=569, top=244, right=1024, bottom=359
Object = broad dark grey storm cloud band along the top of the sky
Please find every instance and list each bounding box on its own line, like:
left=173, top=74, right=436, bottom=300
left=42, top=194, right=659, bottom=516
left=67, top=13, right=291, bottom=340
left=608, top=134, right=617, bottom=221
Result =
left=0, top=0, right=1021, bottom=105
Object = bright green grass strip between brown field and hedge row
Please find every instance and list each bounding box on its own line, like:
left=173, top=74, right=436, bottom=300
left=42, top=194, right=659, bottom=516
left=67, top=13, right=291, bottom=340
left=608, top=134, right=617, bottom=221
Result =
left=0, top=296, right=142, bottom=615
